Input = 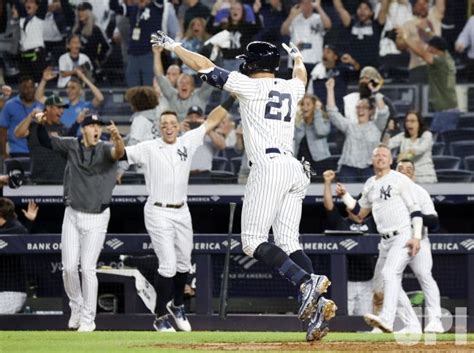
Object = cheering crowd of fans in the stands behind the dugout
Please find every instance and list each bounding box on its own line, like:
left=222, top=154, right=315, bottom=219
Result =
left=0, top=0, right=474, bottom=184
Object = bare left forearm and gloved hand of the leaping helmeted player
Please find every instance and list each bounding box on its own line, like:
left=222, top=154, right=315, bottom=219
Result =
left=150, top=31, right=216, bottom=72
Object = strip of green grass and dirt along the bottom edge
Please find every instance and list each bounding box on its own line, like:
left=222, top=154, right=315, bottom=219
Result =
left=0, top=331, right=474, bottom=353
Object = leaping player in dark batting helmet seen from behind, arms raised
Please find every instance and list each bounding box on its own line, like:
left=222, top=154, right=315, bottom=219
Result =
left=151, top=31, right=336, bottom=341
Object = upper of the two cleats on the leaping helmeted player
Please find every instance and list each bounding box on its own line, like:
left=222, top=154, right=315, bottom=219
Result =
left=298, top=274, right=331, bottom=320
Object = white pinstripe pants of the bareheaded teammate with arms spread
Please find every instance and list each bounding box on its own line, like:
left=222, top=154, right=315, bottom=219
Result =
left=143, top=202, right=193, bottom=278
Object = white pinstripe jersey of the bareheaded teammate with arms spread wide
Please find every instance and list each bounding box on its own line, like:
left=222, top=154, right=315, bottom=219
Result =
left=125, top=124, right=206, bottom=204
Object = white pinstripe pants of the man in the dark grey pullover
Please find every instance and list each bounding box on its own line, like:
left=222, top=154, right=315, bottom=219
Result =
left=61, top=207, right=110, bottom=323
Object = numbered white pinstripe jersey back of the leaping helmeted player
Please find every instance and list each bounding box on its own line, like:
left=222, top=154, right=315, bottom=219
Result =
left=224, top=71, right=305, bottom=163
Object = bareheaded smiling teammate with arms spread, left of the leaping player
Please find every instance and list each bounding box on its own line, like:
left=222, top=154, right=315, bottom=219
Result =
left=125, top=97, right=234, bottom=332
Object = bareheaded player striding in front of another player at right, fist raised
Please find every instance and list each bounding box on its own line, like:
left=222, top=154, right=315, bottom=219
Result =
left=336, top=145, right=423, bottom=332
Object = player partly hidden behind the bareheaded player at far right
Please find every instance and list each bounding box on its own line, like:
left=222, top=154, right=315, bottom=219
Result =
left=397, top=159, right=444, bottom=333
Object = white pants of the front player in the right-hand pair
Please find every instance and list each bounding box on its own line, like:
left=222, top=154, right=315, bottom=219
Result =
left=374, top=227, right=418, bottom=327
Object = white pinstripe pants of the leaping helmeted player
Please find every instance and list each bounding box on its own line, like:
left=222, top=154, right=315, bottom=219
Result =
left=242, top=154, right=310, bottom=256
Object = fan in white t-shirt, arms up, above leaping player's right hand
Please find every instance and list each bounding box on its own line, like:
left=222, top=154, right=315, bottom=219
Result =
left=281, top=0, right=332, bottom=72
